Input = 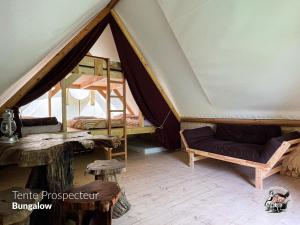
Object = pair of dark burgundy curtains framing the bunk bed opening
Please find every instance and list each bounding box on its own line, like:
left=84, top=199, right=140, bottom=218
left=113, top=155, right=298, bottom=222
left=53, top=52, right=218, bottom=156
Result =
left=12, top=12, right=180, bottom=149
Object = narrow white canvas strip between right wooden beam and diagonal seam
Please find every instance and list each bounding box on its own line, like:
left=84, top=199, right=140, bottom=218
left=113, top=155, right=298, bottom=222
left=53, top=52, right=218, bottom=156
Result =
left=115, top=0, right=214, bottom=116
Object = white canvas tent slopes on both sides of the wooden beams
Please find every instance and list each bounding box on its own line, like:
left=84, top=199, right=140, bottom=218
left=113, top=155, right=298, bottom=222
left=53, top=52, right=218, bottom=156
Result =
left=0, top=0, right=300, bottom=126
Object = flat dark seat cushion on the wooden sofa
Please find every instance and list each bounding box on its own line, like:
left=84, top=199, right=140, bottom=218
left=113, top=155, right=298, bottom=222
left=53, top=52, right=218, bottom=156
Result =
left=190, top=138, right=264, bottom=162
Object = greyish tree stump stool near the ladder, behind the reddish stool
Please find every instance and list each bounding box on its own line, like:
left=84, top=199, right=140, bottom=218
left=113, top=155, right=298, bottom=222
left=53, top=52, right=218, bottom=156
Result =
left=86, top=159, right=131, bottom=219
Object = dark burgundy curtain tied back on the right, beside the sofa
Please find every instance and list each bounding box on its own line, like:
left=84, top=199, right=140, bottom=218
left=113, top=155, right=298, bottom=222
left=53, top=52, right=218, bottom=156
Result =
left=110, top=15, right=180, bottom=149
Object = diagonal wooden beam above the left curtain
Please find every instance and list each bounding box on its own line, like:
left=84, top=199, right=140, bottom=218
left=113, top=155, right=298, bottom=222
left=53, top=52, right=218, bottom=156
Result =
left=0, top=0, right=119, bottom=112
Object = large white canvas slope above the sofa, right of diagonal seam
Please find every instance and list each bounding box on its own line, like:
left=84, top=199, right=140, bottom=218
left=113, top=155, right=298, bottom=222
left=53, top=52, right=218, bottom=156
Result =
left=158, top=0, right=300, bottom=118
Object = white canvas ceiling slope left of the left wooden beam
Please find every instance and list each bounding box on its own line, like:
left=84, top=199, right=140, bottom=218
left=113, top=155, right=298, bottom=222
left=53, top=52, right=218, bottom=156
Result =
left=0, top=0, right=109, bottom=104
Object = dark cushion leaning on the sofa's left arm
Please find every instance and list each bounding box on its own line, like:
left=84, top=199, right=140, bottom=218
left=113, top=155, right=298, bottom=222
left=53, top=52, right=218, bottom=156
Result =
left=183, top=126, right=215, bottom=148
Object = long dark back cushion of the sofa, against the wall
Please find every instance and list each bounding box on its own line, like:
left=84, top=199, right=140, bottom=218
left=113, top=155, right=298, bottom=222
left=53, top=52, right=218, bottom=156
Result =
left=216, top=124, right=281, bottom=145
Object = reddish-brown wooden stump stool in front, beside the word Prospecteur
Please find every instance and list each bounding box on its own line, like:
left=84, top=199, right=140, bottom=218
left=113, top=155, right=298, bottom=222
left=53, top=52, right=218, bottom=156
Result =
left=63, top=180, right=121, bottom=225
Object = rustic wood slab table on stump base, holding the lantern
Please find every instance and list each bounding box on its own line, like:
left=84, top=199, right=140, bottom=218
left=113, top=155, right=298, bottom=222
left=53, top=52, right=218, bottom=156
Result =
left=0, top=132, right=121, bottom=225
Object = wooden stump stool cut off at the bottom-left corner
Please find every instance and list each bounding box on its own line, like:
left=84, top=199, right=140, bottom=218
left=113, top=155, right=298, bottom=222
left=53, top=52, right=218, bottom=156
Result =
left=0, top=188, right=42, bottom=225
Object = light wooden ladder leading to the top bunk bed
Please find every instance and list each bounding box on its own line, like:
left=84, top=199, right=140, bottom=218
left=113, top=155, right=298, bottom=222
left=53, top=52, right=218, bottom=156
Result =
left=106, top=58, right=127, bottom=163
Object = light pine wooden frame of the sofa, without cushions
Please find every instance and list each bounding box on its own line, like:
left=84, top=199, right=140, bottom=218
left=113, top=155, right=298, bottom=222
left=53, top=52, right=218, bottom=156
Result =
left=180, top=130, right=300, bottom=189
